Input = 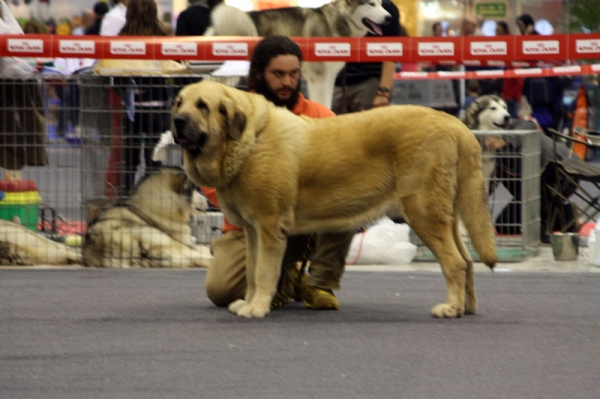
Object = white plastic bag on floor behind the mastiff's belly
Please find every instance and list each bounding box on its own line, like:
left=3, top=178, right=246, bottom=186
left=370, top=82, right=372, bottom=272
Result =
left=346, top=218, right=417, bottom=265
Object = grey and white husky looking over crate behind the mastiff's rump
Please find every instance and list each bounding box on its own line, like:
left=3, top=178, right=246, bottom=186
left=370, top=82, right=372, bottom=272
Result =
left=463, top=94, right=511, bottom=182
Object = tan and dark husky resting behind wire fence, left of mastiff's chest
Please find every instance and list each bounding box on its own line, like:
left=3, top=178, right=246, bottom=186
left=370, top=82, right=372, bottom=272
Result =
left=83, top=167, right=211, bottom=268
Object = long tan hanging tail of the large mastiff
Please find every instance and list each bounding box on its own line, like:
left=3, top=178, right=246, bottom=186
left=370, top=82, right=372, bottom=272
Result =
left=456, top=129, right=498, bottom=269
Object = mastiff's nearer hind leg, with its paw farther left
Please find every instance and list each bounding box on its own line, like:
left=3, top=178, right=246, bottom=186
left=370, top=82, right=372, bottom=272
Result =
left=402, top=195, right=467, bottom=318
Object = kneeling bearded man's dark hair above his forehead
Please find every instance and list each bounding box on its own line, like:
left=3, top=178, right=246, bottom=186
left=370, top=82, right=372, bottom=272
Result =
left=248, top=36, right=302, bottom=90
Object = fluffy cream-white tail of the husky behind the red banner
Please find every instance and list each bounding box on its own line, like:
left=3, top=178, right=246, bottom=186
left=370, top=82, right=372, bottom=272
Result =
left=205, top=3, right=258, bottom=36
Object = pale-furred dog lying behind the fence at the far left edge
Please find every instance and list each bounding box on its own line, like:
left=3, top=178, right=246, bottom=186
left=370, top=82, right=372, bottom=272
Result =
left=0, top=219, right=81, bottom=266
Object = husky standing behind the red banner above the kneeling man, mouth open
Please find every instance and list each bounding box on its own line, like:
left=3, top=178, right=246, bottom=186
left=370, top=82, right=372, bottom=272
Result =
left=206, top=0, right=392, bottom=108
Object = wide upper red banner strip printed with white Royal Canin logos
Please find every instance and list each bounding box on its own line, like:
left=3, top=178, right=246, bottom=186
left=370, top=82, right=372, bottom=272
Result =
left=0, top=34, right=600, bottom=63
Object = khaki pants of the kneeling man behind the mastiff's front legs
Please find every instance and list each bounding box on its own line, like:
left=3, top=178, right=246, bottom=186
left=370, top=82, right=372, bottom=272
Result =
left=206, top=230, right=354, bottom=306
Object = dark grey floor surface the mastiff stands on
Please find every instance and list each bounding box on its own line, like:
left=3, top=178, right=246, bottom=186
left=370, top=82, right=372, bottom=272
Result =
left=0, top=261, right=600, bottom=399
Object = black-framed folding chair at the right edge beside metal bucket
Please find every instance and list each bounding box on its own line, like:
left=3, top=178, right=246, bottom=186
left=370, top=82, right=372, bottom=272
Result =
left=542, top=128, right=600, bottom=236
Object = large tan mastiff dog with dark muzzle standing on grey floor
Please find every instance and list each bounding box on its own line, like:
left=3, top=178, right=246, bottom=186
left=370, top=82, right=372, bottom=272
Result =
left=173, top=81, right=496, bottom=317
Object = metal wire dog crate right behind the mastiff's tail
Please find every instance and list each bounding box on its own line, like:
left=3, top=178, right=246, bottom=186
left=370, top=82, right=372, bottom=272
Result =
left=410, top=130, right=543, bottom=262
